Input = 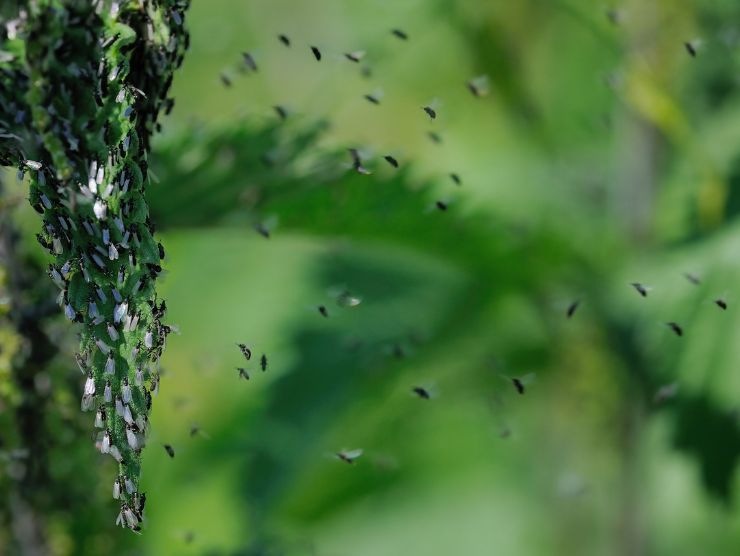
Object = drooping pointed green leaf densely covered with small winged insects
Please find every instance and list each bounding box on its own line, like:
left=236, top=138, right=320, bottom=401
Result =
left=0, top=0, right=188, bottom=531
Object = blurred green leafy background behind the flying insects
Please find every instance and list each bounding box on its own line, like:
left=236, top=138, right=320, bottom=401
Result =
left=4, top=0, right=740, bottom=556
